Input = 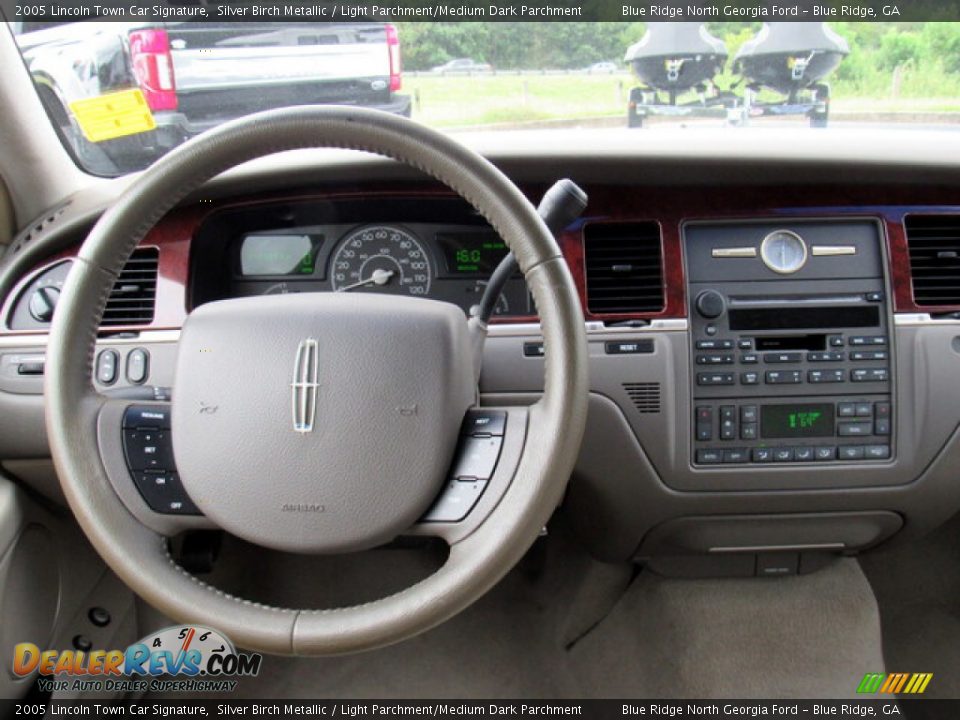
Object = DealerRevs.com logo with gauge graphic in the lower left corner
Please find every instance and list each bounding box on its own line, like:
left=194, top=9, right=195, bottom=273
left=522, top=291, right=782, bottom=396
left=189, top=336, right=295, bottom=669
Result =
left=13, top=625, right=263, bottom=692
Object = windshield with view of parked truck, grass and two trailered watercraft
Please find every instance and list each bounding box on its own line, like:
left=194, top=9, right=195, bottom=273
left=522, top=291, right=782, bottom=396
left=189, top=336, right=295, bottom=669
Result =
left=10, top=13, right=960, bottom=176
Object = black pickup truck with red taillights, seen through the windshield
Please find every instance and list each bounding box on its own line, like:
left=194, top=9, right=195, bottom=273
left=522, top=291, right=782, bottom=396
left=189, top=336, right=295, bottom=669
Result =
left=13, top=22, right=410, bottom=175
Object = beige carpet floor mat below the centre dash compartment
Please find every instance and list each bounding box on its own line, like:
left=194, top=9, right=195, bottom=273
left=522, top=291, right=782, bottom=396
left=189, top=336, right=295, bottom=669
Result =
left=572, top=559, right=883, bottom=698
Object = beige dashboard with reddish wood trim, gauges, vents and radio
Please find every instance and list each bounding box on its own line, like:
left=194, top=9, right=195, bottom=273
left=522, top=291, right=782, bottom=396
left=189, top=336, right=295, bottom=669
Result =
left=0, top=141, right=960, bottom=575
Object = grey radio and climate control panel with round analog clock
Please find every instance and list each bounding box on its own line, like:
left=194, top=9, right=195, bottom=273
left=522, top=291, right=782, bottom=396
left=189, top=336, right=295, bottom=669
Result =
left=685, top=220, right=895, bottom=468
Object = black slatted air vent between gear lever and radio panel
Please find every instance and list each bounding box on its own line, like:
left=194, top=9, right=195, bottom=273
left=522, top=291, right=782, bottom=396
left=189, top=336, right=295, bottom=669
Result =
left=583, top=222, right=663, bottom=314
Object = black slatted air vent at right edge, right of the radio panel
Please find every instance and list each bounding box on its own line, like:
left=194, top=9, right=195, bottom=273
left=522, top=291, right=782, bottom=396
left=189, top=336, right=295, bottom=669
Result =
left=904, top=215, right=960, bottom=305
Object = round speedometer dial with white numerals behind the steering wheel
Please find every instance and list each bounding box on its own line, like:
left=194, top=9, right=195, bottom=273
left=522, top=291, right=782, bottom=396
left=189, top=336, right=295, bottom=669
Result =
left=331, top=225, right=432, bottom=297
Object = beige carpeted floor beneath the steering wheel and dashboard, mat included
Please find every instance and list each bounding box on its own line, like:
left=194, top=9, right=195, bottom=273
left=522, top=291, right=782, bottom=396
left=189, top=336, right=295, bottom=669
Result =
left=145, top=528, right=883, bottom=698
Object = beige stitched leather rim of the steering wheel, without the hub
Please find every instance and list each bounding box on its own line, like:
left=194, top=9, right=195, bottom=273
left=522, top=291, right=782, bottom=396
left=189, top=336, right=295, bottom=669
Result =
left=45, top=107, right=588, bottom=655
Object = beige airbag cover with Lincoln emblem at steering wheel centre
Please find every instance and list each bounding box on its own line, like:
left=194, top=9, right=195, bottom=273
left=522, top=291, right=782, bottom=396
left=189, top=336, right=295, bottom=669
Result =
left=172, top=293, right=476, bottom=552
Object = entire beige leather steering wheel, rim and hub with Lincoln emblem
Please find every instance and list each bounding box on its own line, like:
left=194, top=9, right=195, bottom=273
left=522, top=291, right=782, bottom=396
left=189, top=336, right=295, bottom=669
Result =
left=45, top=107, right=587, bottom=655
